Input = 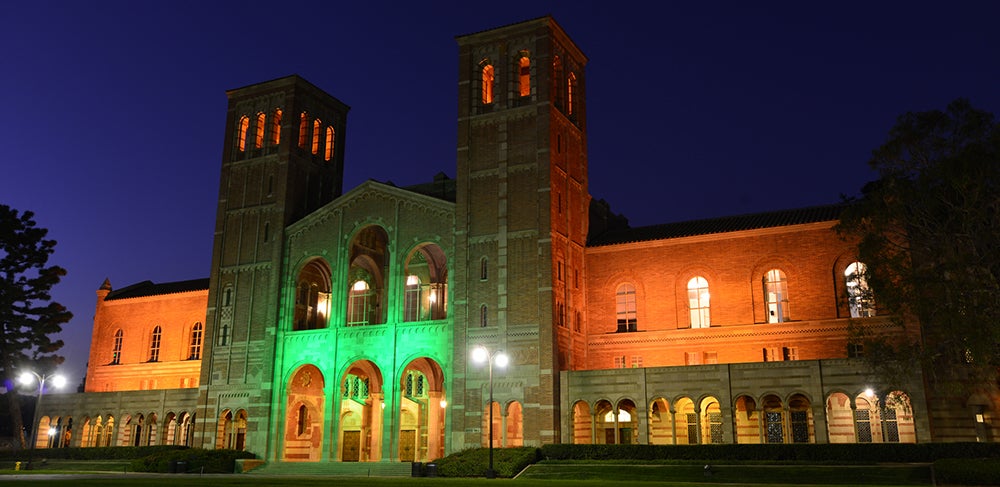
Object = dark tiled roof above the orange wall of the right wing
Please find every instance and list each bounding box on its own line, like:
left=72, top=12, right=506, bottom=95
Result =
left=587, top=204, right=845, bottom=247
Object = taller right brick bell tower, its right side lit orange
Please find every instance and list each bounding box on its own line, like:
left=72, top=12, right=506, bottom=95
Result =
left=453, top=17, right=590, bottom=450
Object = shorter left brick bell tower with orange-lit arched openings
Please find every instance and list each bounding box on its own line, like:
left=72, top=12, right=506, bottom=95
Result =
left=195, top=75, right=349, bottom=452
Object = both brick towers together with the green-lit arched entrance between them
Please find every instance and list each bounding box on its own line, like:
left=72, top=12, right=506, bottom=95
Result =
left=195, top=17, right=590, bottom=461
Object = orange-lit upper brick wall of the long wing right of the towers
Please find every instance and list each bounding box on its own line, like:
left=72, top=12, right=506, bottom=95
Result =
left=585, top=214, right=916, bottom=369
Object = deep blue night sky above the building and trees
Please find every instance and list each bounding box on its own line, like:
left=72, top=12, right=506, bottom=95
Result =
left=0, top=0, right=1000, bottom=389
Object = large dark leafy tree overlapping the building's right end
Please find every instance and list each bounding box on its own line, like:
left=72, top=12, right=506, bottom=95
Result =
left=838, top=99, right=1000, bottom=400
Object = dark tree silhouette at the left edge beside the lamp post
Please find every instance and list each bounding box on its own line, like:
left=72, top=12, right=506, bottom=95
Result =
left=0, top=205, right=73, bottom=447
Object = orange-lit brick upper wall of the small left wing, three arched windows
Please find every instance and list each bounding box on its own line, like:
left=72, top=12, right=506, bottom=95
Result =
left=85, top=279, right=208, bottom=392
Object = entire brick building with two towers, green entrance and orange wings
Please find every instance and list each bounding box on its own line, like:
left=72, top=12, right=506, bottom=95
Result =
left=38, top=17, right=998, bottom=462
